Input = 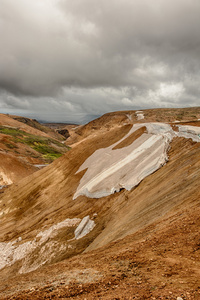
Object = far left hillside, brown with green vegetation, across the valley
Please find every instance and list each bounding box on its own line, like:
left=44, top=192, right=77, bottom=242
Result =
left=0, top=114, right=68, bottom=185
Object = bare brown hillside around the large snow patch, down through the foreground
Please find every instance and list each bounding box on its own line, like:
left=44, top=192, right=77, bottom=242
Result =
left=0, top=109, right=200, bottom=299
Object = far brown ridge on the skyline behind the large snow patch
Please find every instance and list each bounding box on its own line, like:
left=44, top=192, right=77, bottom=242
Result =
left=67, top=107, right=200, bottom=145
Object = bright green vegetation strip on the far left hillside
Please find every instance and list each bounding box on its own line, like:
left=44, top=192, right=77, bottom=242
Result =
left=0, top=126, right=70, bottom=162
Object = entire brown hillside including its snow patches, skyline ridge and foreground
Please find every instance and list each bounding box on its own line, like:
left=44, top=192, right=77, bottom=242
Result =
left=0, top=107, right=200, bottom=300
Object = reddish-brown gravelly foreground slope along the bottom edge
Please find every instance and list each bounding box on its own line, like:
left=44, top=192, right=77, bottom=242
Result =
left=0, top=198, right=200, bottom=300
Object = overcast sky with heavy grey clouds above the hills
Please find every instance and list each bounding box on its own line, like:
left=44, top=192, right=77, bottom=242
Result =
left=0, top=0, right=200, bottom=123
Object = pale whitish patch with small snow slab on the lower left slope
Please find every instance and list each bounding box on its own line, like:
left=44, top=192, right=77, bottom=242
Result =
left=0, top=216, right=95, bottom=273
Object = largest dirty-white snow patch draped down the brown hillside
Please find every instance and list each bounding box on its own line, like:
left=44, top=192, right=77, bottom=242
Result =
left=73, top=123, right=200, bottom=199
